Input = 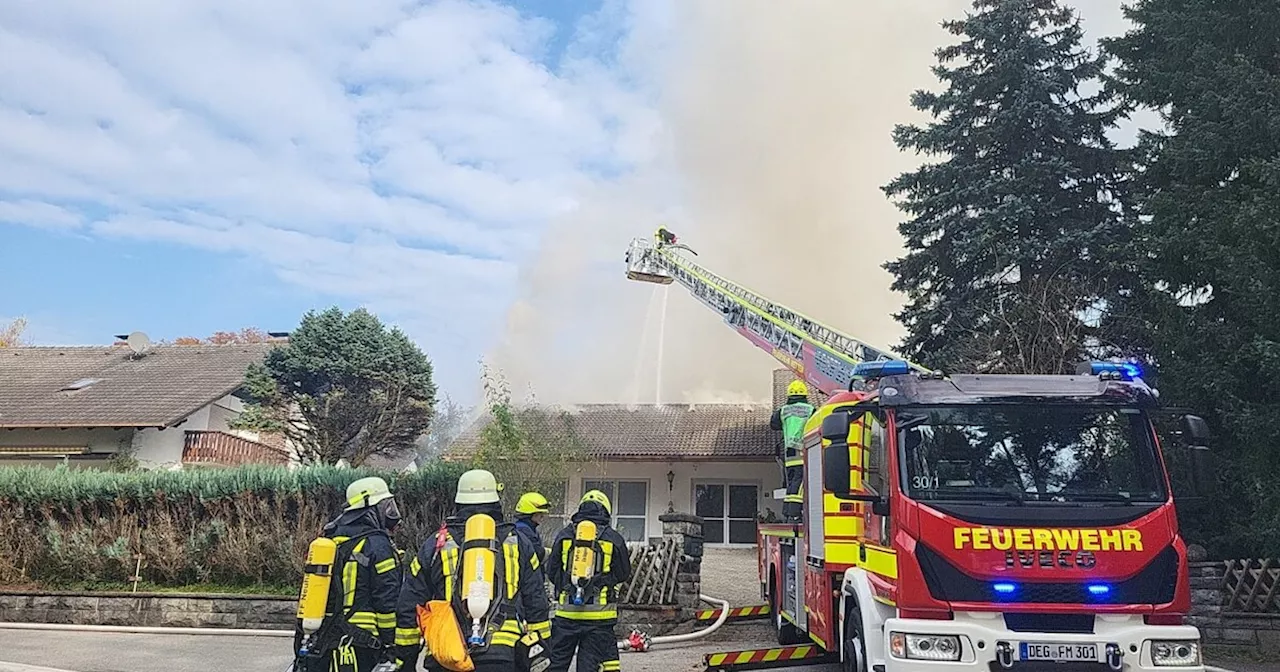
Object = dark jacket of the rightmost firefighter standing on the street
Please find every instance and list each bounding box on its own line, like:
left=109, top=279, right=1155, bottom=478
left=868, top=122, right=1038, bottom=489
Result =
left=547, top=502, right=631, bottom=621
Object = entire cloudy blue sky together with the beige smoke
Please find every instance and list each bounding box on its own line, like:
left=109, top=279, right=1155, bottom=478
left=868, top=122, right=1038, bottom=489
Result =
left=0, top=0, right=1141, bottom=401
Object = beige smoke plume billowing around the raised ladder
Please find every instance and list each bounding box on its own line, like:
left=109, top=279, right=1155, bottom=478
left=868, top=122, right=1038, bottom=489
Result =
left=490, top=0, right=968, bottom=403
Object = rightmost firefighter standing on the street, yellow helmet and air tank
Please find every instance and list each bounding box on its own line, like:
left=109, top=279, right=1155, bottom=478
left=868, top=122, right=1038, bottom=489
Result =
left=547, top=490, right=631, bottom=672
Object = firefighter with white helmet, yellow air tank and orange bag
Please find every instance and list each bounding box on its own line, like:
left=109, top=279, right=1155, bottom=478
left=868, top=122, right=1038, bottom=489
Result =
left=396, top=468, right=550, bottom=672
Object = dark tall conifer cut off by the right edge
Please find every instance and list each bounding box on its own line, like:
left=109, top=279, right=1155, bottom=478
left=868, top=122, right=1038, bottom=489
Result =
left=1106, top=0, right=1280, bottom=557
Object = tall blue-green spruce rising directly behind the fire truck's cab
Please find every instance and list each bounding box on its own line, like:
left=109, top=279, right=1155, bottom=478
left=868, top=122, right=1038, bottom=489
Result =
left=884, top=0, right=1128, bottom=372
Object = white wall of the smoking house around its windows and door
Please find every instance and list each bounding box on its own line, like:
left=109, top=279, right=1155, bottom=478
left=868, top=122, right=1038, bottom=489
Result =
left=566, top=461, right=782, bottom=538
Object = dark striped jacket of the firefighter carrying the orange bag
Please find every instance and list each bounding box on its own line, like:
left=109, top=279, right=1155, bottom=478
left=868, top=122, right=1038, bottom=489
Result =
left=396, top=504, right=550, bottom=664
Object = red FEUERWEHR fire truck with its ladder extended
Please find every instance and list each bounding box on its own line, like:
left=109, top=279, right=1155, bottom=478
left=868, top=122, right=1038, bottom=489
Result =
left=627, top=232, right=1212, bottom=672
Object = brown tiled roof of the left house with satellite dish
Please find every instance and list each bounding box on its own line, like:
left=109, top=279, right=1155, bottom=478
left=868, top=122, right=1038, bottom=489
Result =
left=0, top=343, right=275, bottom=428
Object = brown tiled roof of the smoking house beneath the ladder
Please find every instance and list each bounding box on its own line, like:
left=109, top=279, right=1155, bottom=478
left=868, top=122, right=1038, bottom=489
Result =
left=447, top=403, right=777, bottom=461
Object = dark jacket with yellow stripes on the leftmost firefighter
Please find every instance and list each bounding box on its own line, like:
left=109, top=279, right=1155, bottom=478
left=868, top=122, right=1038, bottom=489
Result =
left=300, top=508, right=401, bottom=649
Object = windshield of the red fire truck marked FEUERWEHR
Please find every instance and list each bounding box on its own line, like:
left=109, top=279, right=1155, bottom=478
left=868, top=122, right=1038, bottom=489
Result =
left=897, top=404, right=1166, bottom=506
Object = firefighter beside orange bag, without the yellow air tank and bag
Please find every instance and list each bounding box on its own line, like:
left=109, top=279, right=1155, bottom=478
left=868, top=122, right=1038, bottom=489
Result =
left=396, top=468, right=550, bottom=672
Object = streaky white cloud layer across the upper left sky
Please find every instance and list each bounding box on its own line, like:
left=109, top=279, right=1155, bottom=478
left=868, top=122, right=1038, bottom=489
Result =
left=0, top=0, right=658, bottom=396
